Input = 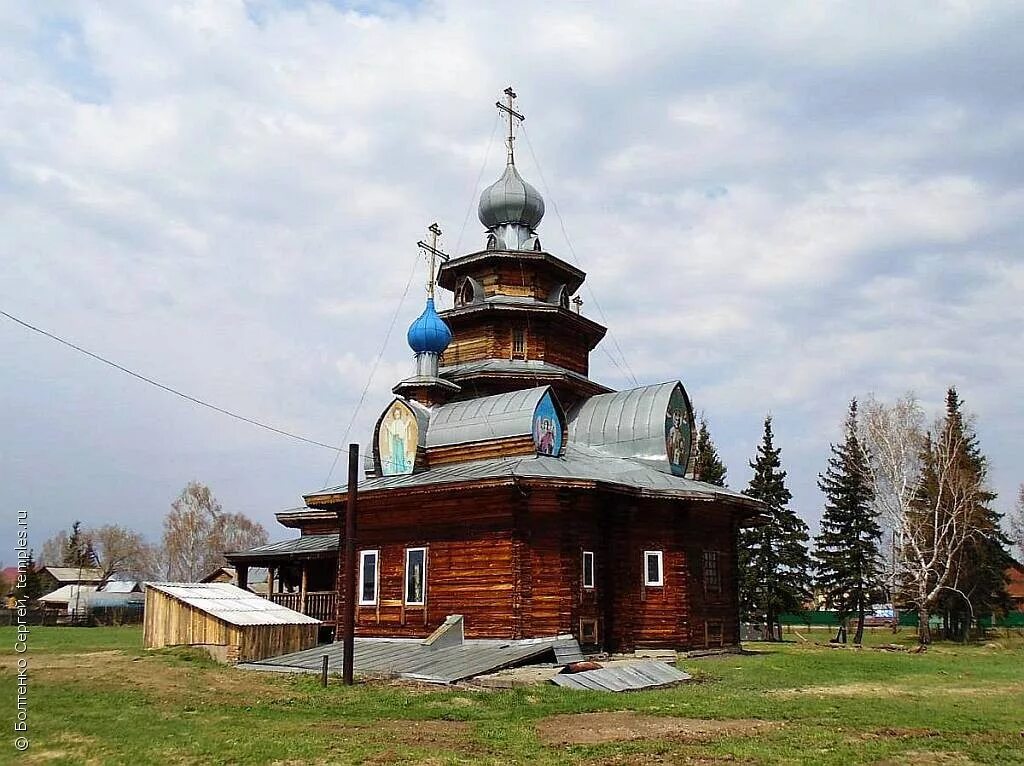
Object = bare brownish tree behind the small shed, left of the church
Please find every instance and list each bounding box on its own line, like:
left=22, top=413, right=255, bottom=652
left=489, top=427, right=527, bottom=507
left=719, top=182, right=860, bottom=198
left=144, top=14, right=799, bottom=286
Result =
left=163, top=481, right=267, bottom=582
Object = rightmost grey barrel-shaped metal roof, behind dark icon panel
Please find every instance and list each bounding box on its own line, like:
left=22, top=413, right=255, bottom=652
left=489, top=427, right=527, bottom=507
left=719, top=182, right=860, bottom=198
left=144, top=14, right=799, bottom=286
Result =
left=568, top=380, right=681, bottom=466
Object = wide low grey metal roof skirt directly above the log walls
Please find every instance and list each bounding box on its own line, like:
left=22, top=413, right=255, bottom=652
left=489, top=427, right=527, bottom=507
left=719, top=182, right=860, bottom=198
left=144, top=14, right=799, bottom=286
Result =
left=305, top=442, right=759, bottom=506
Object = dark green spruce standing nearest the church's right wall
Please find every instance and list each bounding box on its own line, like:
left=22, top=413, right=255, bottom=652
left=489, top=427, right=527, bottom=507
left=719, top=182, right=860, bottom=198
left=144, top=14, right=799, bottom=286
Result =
left=739, top=415, right=810, bottom=640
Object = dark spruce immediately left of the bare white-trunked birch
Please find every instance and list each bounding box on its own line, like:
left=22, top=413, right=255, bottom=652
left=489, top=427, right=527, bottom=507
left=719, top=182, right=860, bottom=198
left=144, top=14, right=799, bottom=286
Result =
left=813, top=399, right=882, bottom=644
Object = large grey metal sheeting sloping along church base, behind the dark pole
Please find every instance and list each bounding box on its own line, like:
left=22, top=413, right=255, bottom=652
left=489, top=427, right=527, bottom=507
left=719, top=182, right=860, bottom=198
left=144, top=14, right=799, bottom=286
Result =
left=239, top=637, right=582, bottom=684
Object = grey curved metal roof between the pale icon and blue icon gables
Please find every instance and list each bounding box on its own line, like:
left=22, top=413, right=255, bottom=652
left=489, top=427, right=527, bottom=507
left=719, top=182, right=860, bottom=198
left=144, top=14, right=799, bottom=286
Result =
left=427, top=386, right=551, bottom=448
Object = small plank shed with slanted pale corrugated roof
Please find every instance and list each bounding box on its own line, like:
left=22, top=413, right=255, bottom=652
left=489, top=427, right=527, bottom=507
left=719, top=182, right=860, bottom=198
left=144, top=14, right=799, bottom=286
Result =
left=142, top=583, right=321, bottom=663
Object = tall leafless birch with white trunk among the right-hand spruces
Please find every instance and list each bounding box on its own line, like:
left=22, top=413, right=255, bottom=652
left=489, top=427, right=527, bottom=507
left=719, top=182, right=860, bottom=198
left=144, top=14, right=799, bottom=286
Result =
left=861, top=394, right=978, bottom=643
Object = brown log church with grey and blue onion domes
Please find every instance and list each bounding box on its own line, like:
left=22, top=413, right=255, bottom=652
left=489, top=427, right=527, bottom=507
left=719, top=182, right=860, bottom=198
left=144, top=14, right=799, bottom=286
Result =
left=228, top=90, right=760, bottom=651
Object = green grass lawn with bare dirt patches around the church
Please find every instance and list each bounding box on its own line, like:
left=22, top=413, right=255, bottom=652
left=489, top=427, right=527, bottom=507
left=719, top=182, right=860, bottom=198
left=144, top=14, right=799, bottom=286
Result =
left=0, top=628, right=1024, bottom=766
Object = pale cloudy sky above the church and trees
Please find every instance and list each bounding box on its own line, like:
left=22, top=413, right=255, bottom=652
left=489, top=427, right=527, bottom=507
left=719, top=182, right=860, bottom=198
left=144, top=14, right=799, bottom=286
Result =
left=0, top=0, right=1024, bottom=558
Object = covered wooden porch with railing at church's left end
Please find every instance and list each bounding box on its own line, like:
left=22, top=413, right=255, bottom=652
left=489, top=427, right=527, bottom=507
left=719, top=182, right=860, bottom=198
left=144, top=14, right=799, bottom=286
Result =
left=224, top=535, right=338, bottom=625
